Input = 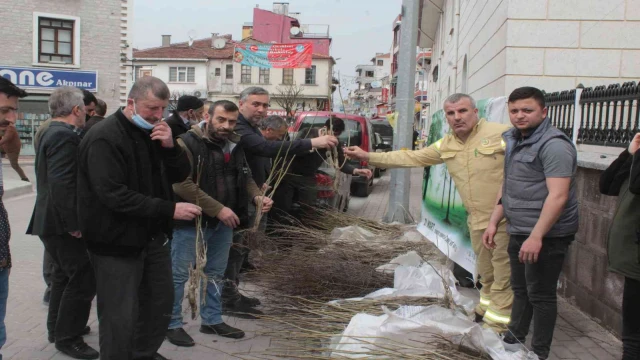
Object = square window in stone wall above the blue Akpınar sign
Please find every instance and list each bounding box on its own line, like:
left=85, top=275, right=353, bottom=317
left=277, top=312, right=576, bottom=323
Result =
left=38, top=17, right=75, bottom=64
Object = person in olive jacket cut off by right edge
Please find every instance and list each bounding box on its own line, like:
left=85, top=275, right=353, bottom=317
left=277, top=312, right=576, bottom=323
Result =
left=600, top=133, right=640, bottom=360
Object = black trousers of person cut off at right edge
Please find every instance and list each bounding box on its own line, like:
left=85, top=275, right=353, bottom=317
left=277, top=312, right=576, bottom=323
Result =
left=622, top=277, right=640, bottom=360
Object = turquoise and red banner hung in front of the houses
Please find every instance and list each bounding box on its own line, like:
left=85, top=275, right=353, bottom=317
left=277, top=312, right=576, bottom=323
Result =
left=233, top=44, right=313, bottom=69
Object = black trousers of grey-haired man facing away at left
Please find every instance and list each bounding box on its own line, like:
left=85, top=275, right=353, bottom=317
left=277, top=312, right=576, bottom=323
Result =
left=40, top=234, right=96, bottom=344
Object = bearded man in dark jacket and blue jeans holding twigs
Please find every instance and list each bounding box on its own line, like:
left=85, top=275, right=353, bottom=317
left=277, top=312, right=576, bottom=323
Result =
left=167, top=100, right=272, bottom=346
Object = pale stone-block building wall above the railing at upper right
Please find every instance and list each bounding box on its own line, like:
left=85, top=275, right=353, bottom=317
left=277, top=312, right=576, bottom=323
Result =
left=421, top=0, right=640, bottom=109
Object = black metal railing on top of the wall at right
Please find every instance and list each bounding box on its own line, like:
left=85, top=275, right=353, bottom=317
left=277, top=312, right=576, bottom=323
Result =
left=545, top=81, right=640, bottom=147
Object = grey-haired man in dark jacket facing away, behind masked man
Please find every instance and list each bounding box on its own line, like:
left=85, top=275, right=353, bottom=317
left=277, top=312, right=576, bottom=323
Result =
left=27, top=87, right=98, bottom=359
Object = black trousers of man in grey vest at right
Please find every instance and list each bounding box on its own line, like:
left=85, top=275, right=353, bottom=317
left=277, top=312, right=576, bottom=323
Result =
left=507, top=235, right=575, bottom=359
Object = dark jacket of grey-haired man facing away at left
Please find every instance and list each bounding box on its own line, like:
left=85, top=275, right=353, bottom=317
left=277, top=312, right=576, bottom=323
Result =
left=27, top=121, right=80, bottom=236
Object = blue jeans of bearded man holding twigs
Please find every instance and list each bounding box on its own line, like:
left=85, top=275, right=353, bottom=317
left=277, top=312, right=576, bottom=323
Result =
left=169, top=223, right=233, bottom=329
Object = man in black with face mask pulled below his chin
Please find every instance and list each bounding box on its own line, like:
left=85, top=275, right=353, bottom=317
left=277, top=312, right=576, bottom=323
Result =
left=78, top=76, right=201, bottom=360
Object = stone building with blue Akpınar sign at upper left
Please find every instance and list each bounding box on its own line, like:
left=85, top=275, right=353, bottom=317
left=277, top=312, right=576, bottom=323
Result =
left=0, top=0, right=133, bottom=155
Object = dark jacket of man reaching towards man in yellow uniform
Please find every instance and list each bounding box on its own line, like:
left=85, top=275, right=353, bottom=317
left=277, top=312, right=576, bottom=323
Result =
left=235, top=114, right=311, bottom=187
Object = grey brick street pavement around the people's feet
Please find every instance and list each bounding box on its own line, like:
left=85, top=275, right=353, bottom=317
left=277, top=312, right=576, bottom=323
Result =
left=0, top=164, right=621, bottom=360
